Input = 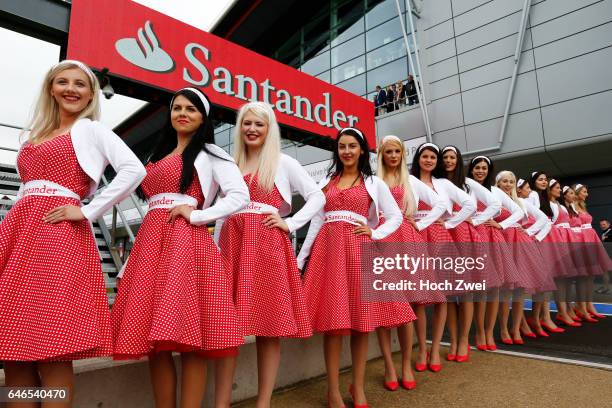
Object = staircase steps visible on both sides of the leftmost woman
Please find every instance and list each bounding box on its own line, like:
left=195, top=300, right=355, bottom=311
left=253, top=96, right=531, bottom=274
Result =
left=0, top=164, right=118, bottom=305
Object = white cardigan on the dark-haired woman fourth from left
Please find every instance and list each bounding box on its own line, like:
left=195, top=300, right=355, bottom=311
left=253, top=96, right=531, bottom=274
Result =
left=297, top=176, right=403, bottom=269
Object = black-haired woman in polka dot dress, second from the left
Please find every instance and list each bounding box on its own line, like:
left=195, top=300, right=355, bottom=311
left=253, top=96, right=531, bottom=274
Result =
left=112, top=88, right=248, bottom=406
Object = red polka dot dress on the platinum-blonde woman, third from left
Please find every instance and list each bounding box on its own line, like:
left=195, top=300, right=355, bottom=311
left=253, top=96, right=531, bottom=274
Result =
left=219, top=175, right=312, bottom=337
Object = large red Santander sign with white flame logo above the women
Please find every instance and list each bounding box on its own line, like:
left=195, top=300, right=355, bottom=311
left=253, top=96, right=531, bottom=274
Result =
left=68, top=0, right=376, bottom=147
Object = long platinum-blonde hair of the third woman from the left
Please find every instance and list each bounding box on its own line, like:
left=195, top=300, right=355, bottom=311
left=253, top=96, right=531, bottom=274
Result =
left=234, top=102, right=280, bottom=192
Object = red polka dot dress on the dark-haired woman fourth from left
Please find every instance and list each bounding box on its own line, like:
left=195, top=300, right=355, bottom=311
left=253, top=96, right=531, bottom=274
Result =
left=304, top=179, right=414, bottom=334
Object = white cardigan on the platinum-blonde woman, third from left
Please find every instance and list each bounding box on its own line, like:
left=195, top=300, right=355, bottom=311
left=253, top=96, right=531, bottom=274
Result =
left=215, top=153, right=325, bottom=243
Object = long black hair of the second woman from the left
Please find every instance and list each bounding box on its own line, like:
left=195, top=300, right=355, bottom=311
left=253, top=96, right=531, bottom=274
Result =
left=136, top=89, right=218, bottom=200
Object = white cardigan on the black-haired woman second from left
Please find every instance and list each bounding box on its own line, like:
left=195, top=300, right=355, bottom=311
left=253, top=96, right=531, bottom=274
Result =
left=189, top=143, right=249, bottom=225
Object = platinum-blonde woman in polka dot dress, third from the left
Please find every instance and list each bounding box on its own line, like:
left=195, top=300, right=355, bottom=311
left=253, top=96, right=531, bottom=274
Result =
left=215, top=102, right=325, bottom=406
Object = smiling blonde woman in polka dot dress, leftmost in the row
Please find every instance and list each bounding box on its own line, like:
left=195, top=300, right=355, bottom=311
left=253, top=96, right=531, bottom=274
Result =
left=0, top=60, right=145, bottom=402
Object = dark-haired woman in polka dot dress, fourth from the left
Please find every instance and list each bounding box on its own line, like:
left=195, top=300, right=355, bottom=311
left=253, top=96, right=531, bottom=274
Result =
left=298, top=128, right=406, bottom=407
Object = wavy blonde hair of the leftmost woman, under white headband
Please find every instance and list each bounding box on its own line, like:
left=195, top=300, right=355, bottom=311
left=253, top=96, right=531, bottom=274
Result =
left=26, top=60, right=100, bottom=142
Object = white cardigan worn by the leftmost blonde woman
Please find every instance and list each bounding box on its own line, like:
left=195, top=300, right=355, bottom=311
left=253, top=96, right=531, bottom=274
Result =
left=17, top=119, right=147, bottom=221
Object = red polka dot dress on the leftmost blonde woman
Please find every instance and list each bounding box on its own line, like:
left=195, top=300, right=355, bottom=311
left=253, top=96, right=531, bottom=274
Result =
left=0, top=134, right=112, bottom=361
